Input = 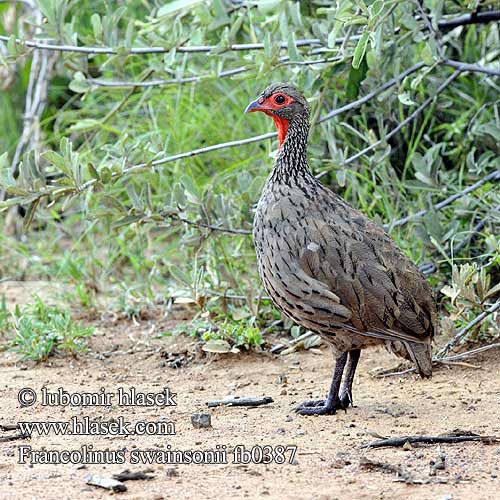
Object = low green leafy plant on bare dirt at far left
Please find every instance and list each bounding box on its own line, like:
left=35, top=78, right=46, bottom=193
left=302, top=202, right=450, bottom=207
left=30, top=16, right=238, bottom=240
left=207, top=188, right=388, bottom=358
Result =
left=11, top=298, right=94, bottom=361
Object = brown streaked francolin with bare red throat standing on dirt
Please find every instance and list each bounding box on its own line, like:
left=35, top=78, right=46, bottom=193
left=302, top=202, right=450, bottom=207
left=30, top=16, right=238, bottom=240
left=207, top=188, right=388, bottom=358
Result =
left=246, top=84, right=437, bottom=415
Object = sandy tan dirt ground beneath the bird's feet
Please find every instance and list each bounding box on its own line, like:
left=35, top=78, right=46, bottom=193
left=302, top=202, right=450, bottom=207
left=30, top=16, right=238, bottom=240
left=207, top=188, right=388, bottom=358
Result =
left=0, top=284, right=500, bottom=500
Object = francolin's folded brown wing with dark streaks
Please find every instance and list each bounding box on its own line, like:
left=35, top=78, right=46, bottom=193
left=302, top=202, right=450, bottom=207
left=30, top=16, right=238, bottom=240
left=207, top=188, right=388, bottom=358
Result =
left=295, top=191, right=437, bottom=342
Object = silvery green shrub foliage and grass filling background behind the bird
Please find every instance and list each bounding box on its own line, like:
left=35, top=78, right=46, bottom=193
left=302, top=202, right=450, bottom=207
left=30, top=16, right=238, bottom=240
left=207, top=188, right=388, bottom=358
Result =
left=0, top=0, right=500, bottom=340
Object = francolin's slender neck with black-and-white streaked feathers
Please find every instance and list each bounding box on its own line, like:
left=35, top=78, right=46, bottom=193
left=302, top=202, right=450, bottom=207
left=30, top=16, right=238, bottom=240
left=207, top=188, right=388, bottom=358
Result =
left=271, top=112, right=312, bottom=181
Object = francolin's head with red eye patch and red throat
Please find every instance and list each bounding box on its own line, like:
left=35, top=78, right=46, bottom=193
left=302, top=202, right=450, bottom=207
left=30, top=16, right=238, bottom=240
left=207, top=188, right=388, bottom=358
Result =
left=245, top=83, right=309, bottom=146
